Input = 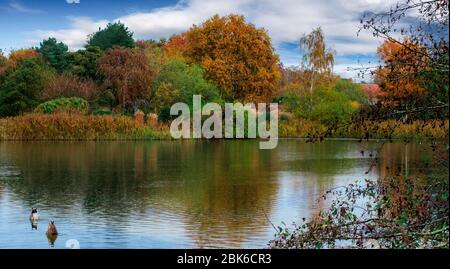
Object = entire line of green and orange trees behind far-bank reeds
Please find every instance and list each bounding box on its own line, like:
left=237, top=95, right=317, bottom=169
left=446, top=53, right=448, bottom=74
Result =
left=0, top=10, right=448, bottom=125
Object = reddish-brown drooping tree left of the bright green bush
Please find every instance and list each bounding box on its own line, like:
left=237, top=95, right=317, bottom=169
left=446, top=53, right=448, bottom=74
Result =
left=98, top=47, right=152, bottom=110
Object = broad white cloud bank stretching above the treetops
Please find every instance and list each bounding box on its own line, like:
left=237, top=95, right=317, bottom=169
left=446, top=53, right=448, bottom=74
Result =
left=28, top=0, right=400, bottom=77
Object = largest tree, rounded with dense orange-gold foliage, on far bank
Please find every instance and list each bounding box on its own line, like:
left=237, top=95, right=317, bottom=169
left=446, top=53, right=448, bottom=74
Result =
left=181, top=15, right=280, bottom=102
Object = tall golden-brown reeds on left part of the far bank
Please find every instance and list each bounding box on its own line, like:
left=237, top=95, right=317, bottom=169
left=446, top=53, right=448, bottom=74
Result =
left=0, top=113, right=170, bottom=140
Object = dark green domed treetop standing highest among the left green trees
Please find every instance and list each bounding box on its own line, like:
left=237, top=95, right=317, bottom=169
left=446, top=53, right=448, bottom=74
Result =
left=87, top=22, right=134, bottom=50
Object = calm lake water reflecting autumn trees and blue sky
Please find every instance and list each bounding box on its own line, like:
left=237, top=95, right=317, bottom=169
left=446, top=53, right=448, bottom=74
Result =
left=0, top=139, right=428, bottom=248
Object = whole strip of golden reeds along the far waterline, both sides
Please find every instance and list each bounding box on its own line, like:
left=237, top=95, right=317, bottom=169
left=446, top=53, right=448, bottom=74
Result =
left=0, top=114, right=449, bottom=141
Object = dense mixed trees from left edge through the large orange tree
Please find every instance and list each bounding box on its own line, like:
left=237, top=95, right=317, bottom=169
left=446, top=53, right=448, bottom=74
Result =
left=0, top=15, right=280, bottom=118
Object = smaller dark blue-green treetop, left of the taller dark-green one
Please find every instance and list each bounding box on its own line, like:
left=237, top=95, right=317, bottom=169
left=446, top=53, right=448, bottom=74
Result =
left=37, top=38, right=69, bottom=73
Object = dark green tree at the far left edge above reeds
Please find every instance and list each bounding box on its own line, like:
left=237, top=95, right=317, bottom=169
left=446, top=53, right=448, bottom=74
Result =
left=0, top=58, right=52, bottom=116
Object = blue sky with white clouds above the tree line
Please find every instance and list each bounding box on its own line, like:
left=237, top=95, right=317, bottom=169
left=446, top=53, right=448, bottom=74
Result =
left=0, top=0, right=400, bottom=79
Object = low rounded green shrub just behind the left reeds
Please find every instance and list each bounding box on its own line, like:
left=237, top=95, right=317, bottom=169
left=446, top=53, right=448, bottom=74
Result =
left=34, top=97, right=89, bottom=114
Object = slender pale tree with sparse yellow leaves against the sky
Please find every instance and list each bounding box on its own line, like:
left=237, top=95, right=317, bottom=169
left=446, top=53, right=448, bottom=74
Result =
left=300, top=27, right=334, bottom=92
